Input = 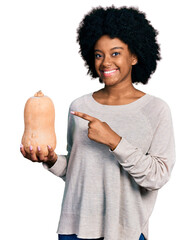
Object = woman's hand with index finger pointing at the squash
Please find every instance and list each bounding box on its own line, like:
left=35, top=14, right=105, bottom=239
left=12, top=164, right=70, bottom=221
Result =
left=71, top=111, right=121, bottom=150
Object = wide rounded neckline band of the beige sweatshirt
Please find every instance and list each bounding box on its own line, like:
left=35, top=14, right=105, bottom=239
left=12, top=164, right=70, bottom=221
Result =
left=86, top=92, right=151, bottom=110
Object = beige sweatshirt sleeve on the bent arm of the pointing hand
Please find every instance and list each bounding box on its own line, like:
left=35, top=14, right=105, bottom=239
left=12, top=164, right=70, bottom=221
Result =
left=110, top=105, right=175, bottom=190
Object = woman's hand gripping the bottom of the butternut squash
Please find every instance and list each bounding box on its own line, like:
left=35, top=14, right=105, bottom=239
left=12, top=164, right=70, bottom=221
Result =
left=20, top=144, right=58, bottom=168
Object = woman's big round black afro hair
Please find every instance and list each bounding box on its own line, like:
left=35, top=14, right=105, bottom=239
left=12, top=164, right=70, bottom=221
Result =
left=77, top=6, right=161, bottom=84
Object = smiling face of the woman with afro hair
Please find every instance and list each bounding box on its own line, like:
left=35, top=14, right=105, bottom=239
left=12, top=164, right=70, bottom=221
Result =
left=94, top=35, right=137, bottom=86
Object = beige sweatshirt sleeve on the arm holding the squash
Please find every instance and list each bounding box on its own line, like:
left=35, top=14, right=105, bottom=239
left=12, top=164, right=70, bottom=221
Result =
left=43, top=107, right=74, bottom=180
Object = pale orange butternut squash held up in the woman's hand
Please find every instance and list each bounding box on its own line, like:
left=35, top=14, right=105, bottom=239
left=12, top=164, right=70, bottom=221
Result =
left=22, top=91, right=56, bottom=156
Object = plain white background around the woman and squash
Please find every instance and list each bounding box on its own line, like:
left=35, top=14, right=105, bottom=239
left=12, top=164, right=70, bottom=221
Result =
left=0, top=0, right=196, bottom=240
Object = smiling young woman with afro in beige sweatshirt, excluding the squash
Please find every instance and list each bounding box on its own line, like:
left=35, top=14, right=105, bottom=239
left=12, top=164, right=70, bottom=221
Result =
left=21, top=6, right=175, bottom=240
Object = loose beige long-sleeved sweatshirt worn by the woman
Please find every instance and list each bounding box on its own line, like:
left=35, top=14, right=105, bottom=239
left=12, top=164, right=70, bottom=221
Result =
left=45, top=93, right=175, bottom=240
